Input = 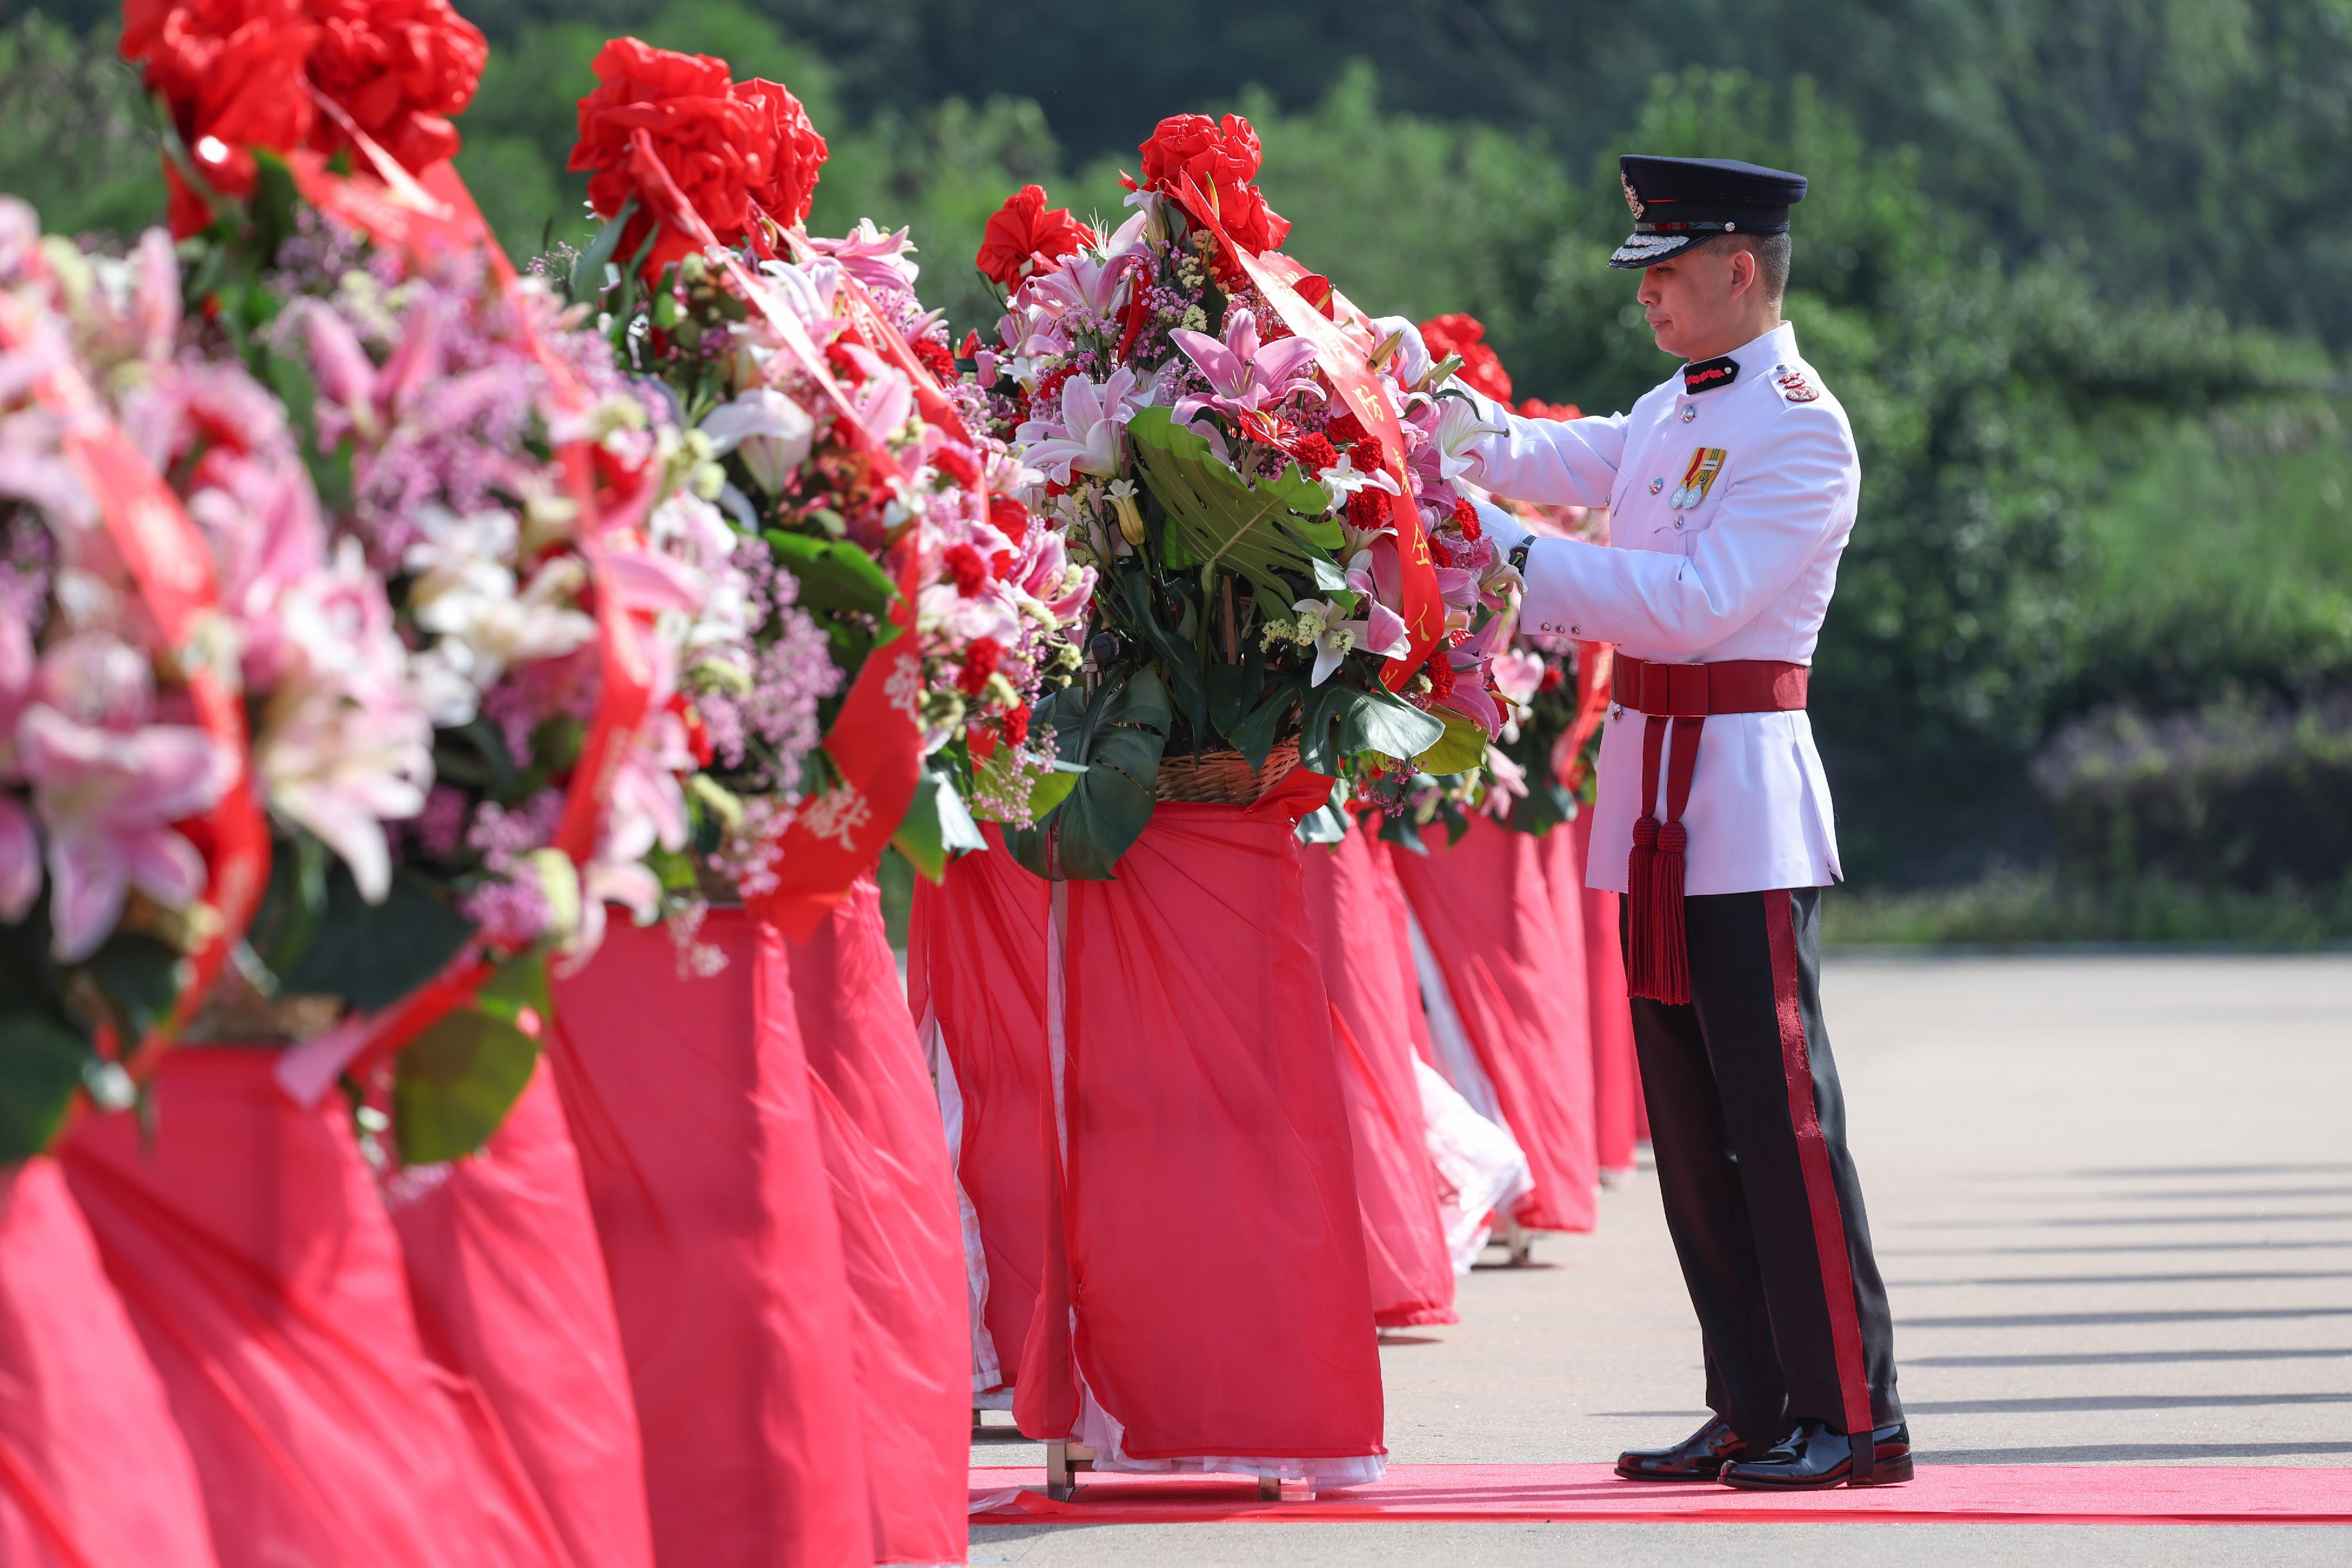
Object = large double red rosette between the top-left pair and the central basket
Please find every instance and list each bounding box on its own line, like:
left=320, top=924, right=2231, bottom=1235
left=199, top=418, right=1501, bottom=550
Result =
left=567, top=38, right=828, bottom=278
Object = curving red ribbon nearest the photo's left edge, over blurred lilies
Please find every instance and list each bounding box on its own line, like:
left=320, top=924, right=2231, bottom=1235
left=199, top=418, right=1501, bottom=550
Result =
left=0, top=296, right=270, bottom=1076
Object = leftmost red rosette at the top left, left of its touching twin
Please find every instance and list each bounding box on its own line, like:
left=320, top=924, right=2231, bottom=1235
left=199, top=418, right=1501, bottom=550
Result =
left=122, top=0, right=318, bottom=238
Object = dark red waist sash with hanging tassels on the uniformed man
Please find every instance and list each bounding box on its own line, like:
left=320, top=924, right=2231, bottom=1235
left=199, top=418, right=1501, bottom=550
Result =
left=1613, top=654, right=1811, bottom=1004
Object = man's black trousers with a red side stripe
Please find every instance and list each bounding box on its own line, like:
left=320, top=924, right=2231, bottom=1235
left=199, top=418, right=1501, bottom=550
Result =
left=1632, top=888, right=1903, bottom=1443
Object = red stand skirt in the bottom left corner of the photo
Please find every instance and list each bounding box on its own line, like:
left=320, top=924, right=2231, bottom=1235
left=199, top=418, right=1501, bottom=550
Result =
left=0, top=1159, right=219, bottom=1568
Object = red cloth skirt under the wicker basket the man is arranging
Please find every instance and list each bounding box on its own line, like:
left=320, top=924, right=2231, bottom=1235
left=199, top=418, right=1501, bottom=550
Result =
left=1014, top=801, right=1385, bottom=1486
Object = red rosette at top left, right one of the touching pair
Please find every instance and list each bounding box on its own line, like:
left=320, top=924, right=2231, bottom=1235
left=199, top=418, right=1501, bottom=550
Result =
left=308, top=0, right=489, bottom=169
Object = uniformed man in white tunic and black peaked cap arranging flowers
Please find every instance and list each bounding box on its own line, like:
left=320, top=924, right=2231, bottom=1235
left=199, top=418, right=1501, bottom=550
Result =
left=1383, top=155, right=1912, bottom=1488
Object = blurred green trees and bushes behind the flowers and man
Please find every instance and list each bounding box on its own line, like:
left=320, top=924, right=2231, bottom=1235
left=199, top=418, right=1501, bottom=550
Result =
left=0, top=0, right=2352, bottom=902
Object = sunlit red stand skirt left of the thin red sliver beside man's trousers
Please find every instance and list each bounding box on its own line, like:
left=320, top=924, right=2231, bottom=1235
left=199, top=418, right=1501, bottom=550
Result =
left=1390, top=815, right=1599, bottom=1229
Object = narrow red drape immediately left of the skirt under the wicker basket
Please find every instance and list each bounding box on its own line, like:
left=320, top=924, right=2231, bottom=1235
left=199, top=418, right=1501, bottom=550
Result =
left=906, top=823, right=1051, bottom=1396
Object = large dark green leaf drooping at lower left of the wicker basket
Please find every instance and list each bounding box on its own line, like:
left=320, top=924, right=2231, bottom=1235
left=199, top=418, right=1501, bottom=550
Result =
left=1004, top=670, right=1176, bottom=881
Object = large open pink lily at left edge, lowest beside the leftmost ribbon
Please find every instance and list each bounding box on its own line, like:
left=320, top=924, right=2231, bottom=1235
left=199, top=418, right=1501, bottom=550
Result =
left=16, top=703, right=238, bottom=964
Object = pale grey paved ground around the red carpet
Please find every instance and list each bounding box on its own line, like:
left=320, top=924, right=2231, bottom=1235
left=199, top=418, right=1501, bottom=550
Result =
left=971, top=957, right=2352, bottom=1568
